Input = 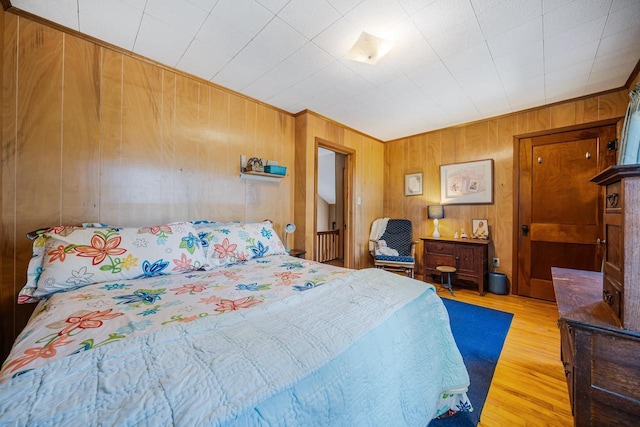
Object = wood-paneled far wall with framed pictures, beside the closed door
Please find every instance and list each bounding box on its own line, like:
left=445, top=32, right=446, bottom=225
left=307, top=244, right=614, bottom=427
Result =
left=384, top=90, right=637, bottom=290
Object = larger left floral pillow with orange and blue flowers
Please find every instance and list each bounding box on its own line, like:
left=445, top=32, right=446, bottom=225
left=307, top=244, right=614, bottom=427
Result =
left=33, top=222, right=207, bottom=298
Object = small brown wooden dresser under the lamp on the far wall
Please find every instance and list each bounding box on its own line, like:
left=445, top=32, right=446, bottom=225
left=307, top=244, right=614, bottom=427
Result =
left=420, top=237, right=491, bottom=295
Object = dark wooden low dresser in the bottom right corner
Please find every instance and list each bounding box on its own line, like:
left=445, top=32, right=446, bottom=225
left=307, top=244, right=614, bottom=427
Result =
left=551, top=267, right=640, bottom=427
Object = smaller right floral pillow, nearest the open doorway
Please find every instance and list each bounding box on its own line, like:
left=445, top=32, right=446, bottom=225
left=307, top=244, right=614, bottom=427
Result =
left=198, top=221, right=286, bottom=268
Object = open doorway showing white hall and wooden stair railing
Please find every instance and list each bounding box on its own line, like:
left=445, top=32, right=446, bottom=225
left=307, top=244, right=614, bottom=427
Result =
left=313, top=140, right=353, bottom=267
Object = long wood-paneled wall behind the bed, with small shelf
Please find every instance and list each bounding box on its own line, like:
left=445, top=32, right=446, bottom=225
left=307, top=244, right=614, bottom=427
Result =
left=0, top=12, right=295, bottom=356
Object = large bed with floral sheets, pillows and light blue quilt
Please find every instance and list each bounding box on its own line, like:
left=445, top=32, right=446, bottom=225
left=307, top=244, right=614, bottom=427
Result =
left=0, top=221, right=472, bottom=426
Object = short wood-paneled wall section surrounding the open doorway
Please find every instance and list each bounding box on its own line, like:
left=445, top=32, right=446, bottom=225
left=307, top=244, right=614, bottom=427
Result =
left=295, top=112, right=385, bottom=268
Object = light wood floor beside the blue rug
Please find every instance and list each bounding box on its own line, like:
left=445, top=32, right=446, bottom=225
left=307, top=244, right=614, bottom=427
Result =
left=436, top=284, right=573, bottom=427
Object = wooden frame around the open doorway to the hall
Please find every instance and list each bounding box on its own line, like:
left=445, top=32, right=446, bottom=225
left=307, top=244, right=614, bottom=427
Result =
left=312, top=137, right=356, bottom=268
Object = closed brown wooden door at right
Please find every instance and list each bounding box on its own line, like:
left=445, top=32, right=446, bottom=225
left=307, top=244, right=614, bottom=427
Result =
left=516, top=125, right=616, bottom=301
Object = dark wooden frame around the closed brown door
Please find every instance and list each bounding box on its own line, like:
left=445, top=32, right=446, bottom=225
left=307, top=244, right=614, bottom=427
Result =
left=511, top=117, right=624, bottom=295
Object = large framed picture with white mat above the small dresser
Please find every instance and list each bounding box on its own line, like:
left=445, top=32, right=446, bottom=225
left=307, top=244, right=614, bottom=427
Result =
left=440, top=159, right=493, bottom=205
